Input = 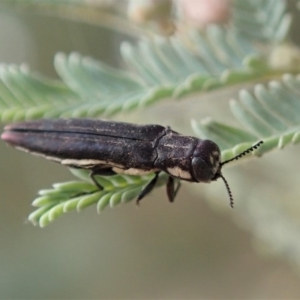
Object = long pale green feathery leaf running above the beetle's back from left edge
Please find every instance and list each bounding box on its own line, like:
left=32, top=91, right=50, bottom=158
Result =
left=0, top=26, right=272, bottom=122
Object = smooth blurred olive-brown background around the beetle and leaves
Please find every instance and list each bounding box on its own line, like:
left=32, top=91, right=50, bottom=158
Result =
left=0, top=4, right=300, bottom=299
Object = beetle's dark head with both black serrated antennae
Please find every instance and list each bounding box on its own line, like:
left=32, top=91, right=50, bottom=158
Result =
left=192, top=140, right=263, bottom=208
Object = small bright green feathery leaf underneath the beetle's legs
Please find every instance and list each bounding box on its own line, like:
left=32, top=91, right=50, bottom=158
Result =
left=28, top=169, right=167, bottom=227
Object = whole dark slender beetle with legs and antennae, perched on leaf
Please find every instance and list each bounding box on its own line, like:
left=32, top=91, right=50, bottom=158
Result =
left=1, top=119, right=263, bottom=207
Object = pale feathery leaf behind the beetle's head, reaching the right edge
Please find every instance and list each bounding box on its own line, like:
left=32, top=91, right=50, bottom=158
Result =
left=192, top=74, right=300, bottom=160
